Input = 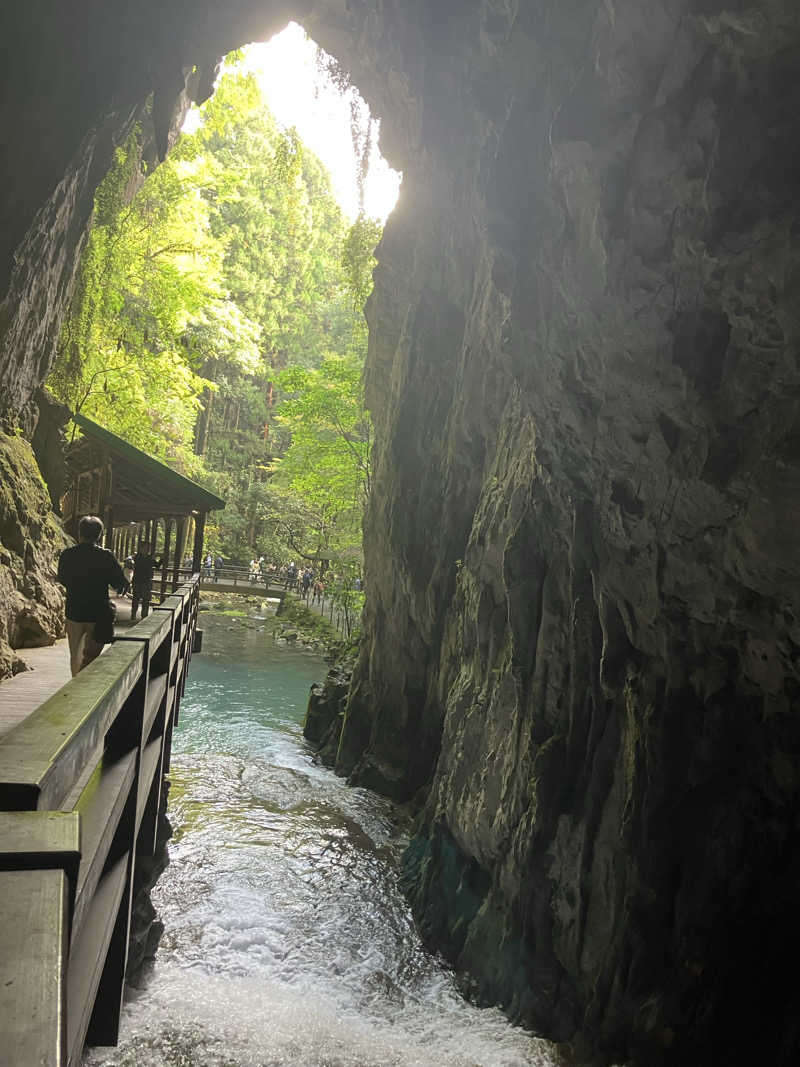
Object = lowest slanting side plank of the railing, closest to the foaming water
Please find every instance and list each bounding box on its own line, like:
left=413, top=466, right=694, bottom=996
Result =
left=66, top=853, right=130, bottom=1064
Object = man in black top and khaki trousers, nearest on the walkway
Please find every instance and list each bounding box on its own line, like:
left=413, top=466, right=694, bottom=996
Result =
left=59, top=515, right=129, bottom=678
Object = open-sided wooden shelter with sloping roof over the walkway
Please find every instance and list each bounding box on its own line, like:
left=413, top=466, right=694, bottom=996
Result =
left=61, top=415, right=225, bottom=580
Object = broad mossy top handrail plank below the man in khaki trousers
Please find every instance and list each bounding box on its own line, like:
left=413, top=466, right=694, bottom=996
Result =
left=0, top=641, right=144, bottom=811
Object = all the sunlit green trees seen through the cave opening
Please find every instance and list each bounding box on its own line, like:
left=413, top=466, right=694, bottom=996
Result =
left=48, top=62, right=380, bottom=570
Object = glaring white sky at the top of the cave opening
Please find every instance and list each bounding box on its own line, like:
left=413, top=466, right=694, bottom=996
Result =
left=183, top=22, right=401, bottom=222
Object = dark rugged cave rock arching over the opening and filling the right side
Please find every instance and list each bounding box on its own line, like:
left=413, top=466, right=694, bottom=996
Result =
left=0, top=0, right=800, bottom=1067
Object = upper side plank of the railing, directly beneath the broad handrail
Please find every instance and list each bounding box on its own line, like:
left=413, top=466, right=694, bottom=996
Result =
left=73, top=752, right=137, bottom=940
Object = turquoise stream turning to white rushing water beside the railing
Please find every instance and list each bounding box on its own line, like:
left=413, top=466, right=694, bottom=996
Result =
left=84, top=616, right=558, bottom=1067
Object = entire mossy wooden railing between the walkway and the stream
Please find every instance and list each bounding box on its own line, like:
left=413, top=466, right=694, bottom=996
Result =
left=0, top=575, right=198, bottom=1067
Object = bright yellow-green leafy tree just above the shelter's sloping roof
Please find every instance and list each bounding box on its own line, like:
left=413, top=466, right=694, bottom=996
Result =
left=48, top=130, right=221, bottom=471
